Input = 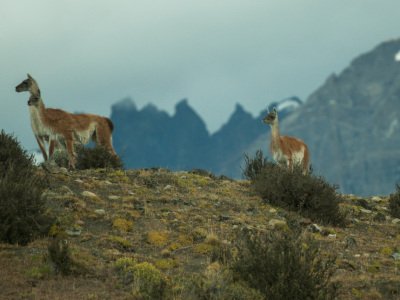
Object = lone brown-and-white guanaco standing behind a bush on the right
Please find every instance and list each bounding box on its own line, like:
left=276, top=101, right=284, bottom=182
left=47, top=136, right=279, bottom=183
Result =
left=263, top=107, right=310, bottom=174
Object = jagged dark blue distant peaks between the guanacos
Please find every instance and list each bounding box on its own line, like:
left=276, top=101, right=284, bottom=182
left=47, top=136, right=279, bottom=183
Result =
left=111, top=97, right=301, bottom=178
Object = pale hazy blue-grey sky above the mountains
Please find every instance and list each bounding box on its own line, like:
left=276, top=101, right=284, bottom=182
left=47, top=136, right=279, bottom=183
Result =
left=0, top=0, right=400, bottom=149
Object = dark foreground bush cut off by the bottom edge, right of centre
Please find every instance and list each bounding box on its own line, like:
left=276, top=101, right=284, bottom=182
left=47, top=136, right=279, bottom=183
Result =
left=232, top=231, right=337, bottom=300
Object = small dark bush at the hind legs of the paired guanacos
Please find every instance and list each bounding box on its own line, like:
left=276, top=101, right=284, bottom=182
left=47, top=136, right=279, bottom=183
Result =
left=76, top=146, right=123, bottom=170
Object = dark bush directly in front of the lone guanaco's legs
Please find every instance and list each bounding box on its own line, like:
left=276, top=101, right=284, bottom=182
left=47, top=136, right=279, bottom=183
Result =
left=246, top=152, right=345, bottom=225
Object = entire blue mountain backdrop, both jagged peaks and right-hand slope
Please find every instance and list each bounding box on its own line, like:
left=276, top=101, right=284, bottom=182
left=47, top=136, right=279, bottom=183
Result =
left=111, top=40, right=400, bottom=195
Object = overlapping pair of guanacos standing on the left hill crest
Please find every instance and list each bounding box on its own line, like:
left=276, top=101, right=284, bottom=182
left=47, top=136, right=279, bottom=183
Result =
left=15, top=74, right=116, bottom=168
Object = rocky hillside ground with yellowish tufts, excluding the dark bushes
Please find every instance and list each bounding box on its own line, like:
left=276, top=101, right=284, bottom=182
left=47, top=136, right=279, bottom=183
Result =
left=0, top=169, right=400, bottom=299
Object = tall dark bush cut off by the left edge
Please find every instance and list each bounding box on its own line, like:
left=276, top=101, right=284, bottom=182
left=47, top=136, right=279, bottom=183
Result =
left=0, top=131, right=50, bottom=245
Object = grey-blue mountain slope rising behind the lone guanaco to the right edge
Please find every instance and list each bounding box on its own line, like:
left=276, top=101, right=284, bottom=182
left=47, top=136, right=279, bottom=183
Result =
left=248, top=40, right=400, bottom=195
